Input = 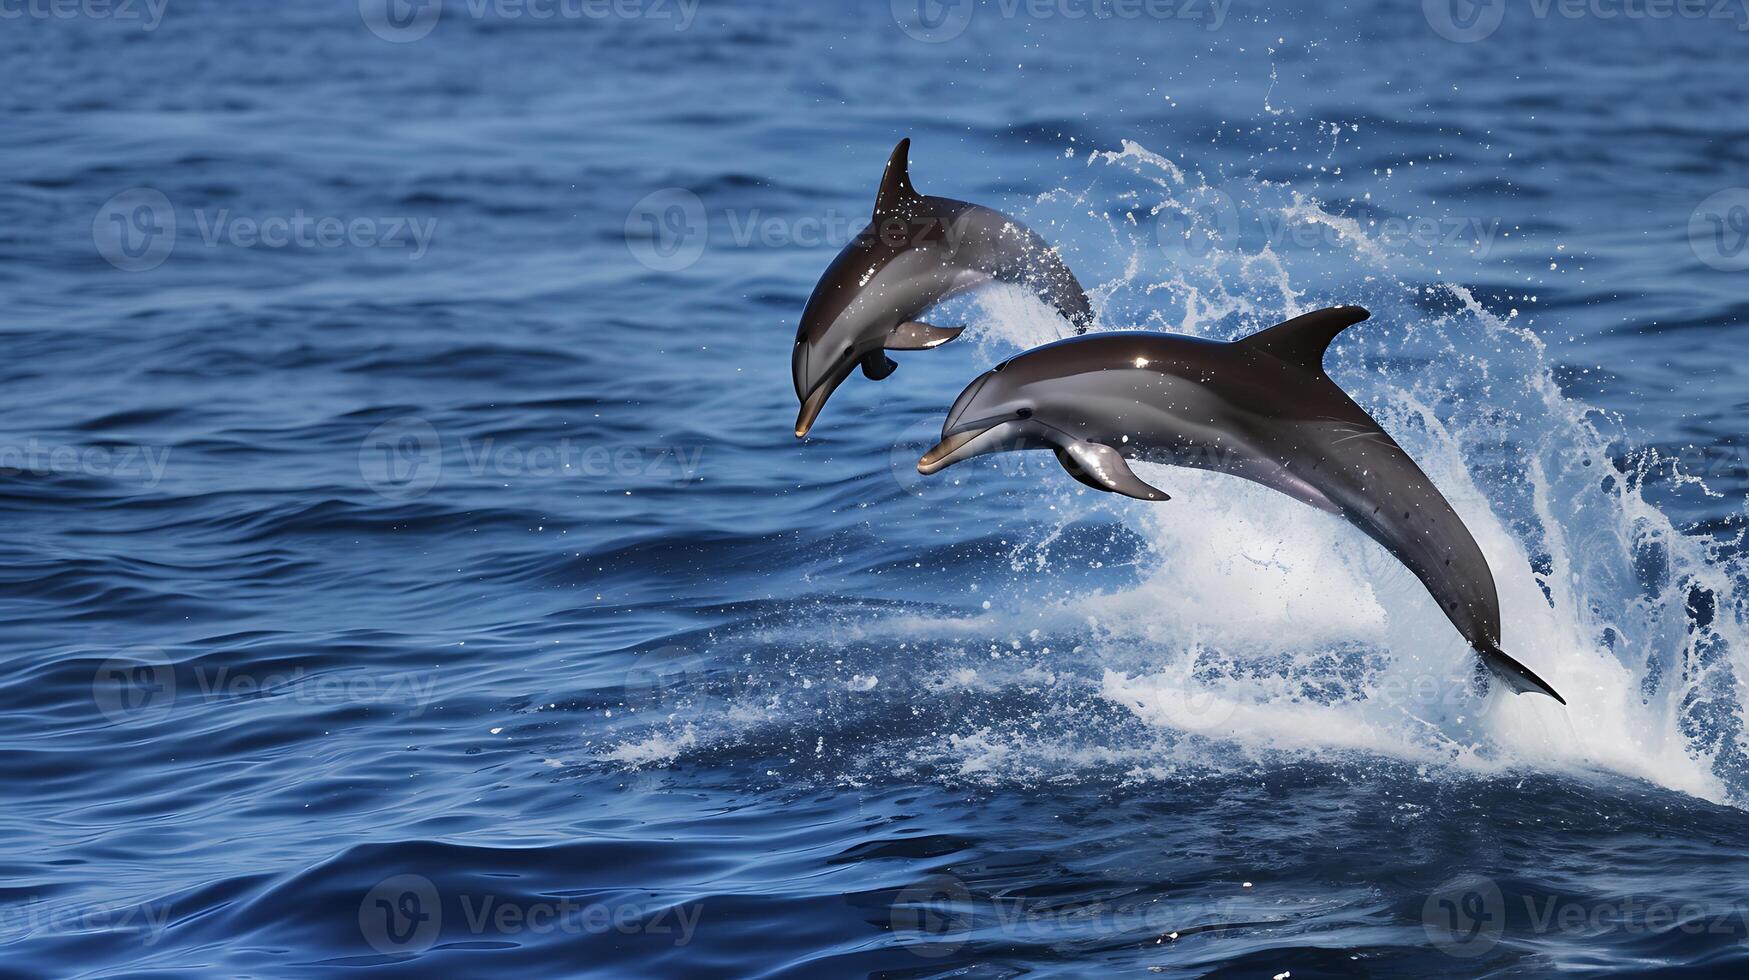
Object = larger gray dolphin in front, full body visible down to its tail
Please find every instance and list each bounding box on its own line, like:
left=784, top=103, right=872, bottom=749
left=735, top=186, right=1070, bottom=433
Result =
left=916, top=306, right=1567, bottom=704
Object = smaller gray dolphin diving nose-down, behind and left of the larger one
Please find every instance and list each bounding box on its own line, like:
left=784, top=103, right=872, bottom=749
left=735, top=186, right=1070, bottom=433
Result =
left=791, top=140, right=1093, bottom=439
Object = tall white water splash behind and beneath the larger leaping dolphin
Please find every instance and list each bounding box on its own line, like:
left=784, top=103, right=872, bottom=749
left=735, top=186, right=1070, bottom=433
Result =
left=981, top=144, right=1749, bottom=800
